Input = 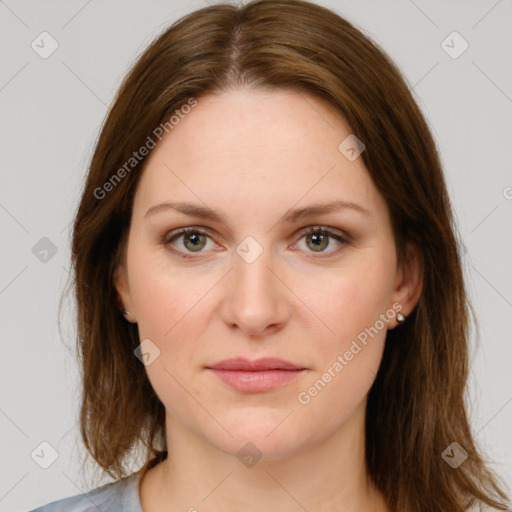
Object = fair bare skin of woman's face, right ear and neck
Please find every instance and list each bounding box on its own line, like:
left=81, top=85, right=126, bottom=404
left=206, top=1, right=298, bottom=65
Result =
left=115, top=89, right=422, bottom=512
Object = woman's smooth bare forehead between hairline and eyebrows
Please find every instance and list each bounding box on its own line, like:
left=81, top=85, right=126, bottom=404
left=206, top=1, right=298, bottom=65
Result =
left=134, top=89, right=385, bottom=222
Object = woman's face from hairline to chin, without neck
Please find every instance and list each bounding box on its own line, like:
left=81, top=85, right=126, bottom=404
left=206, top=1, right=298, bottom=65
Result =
left=116, top=90, right=414, bottom=460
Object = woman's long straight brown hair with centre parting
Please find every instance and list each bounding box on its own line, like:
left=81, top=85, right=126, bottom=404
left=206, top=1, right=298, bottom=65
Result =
left=66, top=0, right=507, bottom=512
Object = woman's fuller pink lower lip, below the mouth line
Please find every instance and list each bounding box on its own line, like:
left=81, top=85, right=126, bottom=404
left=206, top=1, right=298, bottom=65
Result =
left=209, top=368, right=306, bottom=393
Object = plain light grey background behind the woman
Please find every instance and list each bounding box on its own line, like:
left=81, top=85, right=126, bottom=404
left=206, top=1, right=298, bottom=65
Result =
left=0, top=0, right=512, bottom=511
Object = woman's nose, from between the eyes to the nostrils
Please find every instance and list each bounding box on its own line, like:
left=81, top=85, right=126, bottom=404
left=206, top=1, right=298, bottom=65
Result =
left=223, top=240, right=287, bottom=333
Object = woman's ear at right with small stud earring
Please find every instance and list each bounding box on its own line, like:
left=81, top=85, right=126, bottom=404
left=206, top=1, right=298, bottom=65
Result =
left=393, top=242, right=424, bottom=327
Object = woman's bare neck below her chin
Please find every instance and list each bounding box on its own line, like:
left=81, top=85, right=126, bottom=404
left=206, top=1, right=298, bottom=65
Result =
left=141, top=402, right=387, bottom=512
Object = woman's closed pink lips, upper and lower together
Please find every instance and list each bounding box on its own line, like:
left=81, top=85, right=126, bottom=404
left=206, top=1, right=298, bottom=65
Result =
left=206, top=357, right=307, bottom=393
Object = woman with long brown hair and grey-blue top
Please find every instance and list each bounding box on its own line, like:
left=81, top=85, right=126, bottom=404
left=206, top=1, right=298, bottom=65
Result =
left=30, top=0, right=508, bottom=512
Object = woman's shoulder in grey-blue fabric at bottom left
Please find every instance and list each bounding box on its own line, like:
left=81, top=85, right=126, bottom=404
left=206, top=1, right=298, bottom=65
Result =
left=30, top=473, right=142, bottom=512
